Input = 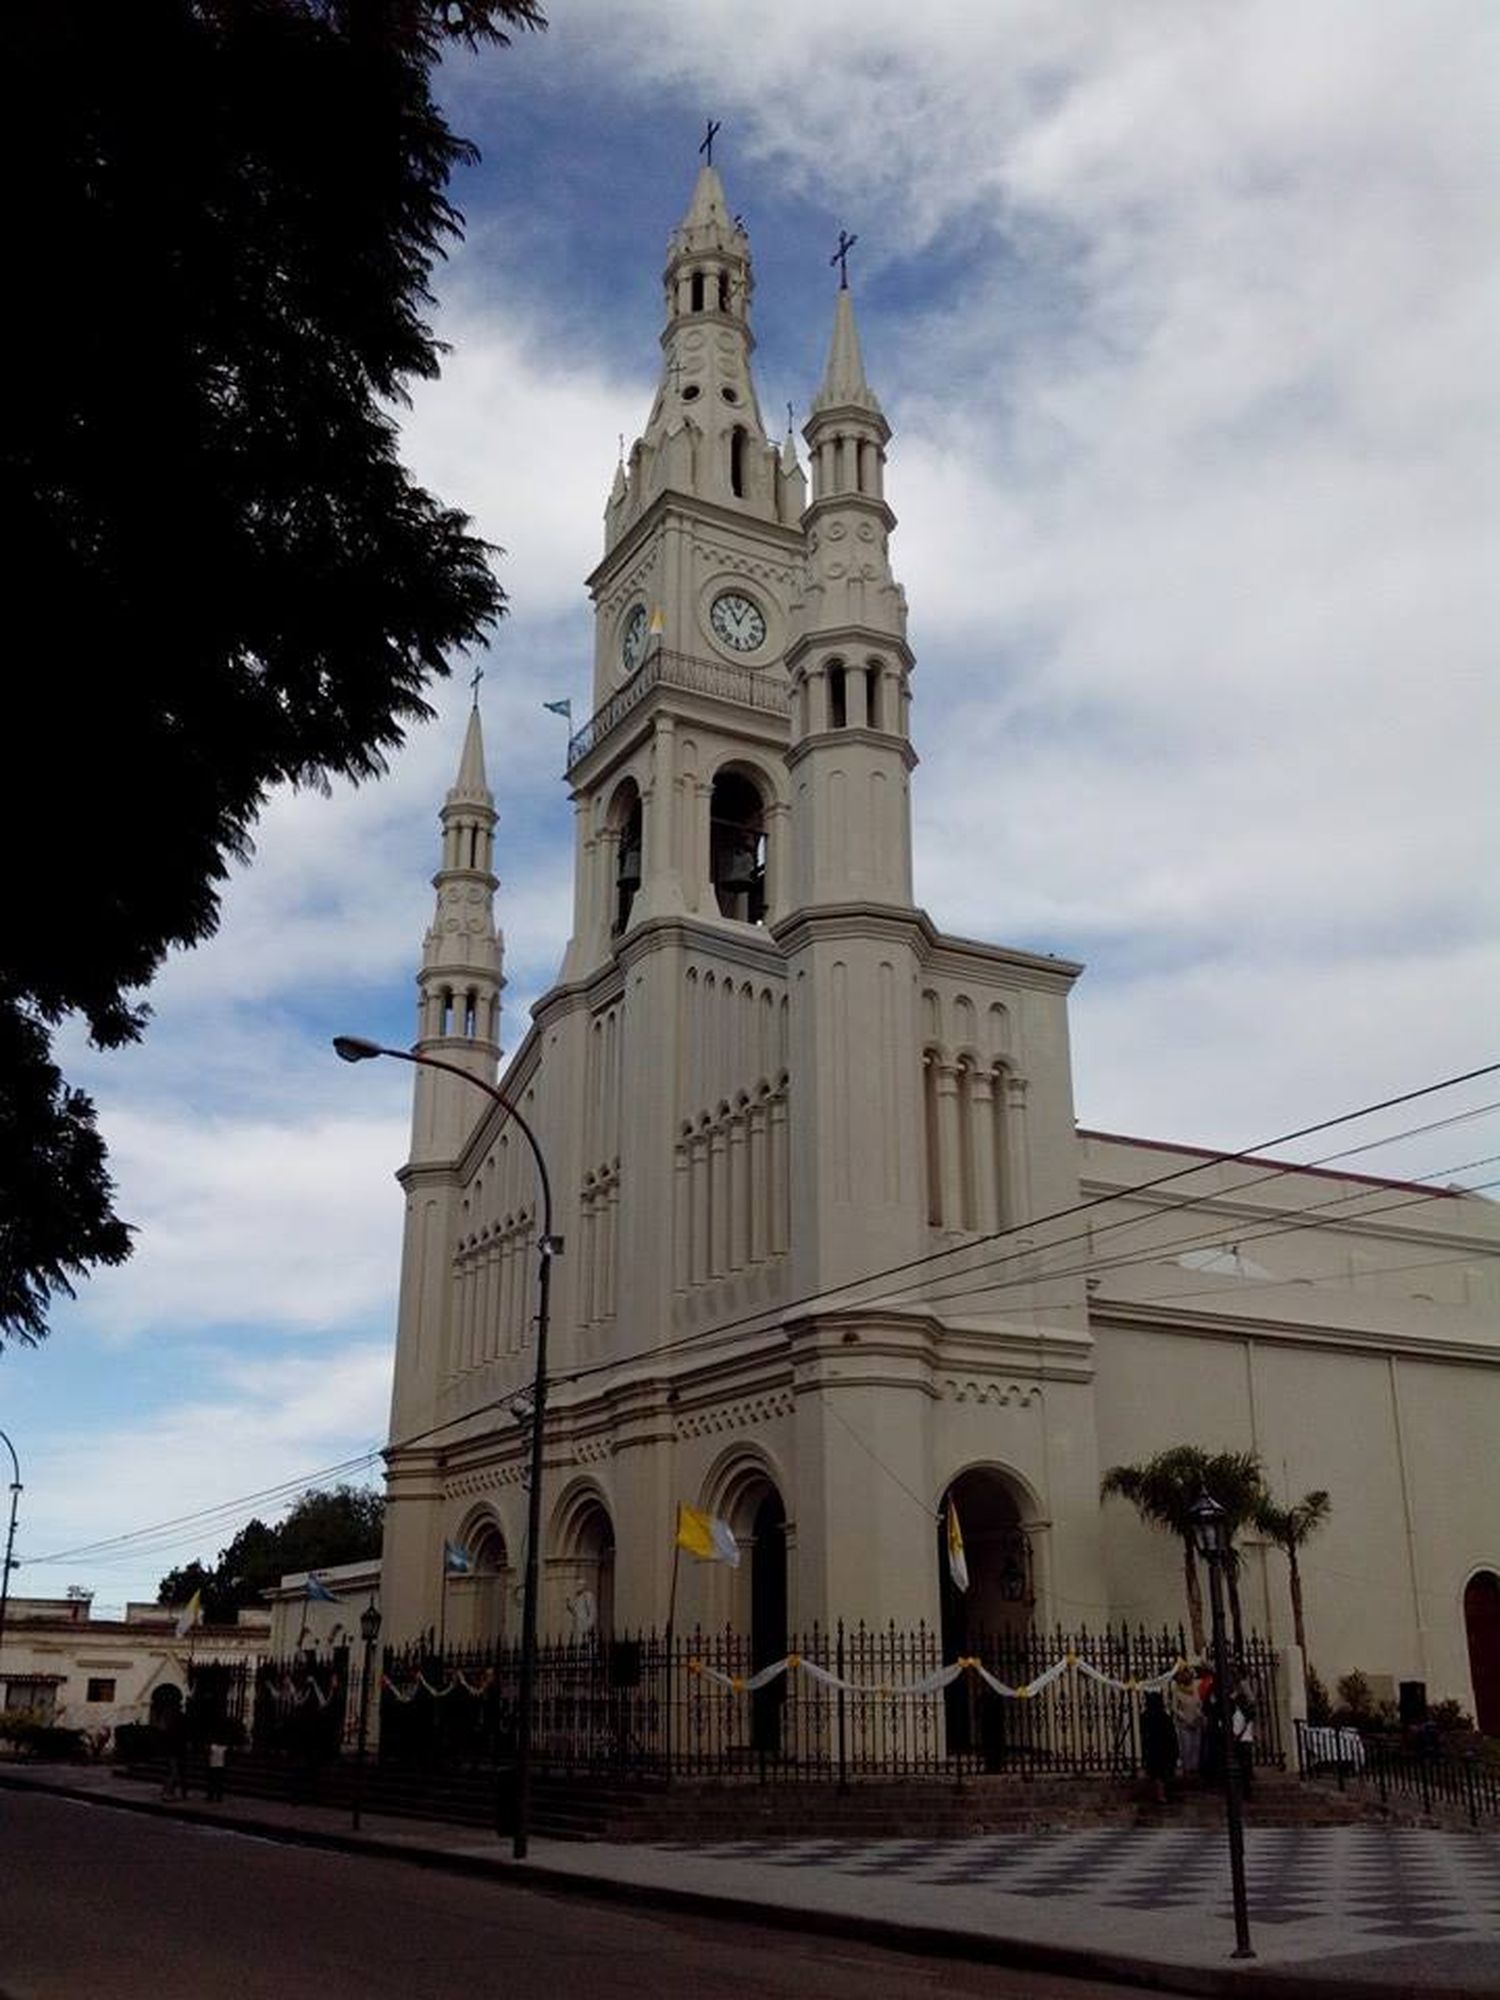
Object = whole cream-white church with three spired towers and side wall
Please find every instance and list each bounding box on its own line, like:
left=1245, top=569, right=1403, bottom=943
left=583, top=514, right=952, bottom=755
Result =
left=382, top=166, right=1500, bottom=1728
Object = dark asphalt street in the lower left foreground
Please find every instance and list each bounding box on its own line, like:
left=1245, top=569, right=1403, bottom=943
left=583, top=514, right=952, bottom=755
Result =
left=0, top=1790, right=1176, bottom=2000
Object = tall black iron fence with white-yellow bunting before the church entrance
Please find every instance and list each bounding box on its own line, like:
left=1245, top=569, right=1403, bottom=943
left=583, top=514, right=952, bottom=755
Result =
left=380, top=1622, right=1284, bottom=1782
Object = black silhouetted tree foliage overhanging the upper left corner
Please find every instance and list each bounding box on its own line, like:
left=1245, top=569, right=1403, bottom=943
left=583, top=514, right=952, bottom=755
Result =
left=0, top=0, right=544, bottom=1342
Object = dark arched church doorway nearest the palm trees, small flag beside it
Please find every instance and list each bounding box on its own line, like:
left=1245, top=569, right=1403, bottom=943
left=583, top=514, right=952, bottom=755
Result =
left=936, top=1466, right=1036, bottom=1770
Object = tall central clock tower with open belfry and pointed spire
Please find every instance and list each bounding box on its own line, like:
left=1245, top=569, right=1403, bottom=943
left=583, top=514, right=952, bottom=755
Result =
left=564, top=164, right=806, bottom=978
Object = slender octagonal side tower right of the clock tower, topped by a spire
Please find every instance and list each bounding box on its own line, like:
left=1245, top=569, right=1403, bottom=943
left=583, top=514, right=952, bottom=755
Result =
left=776, top=280, right=926, bottom=1294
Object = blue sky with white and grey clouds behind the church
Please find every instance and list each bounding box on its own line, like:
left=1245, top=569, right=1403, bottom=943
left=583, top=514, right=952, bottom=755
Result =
left=0, top=0, right=1500, bottom=1614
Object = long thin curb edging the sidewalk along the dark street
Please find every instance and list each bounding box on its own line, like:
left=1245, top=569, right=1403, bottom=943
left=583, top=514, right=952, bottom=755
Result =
left=0, top=1770, right=1486, bottom=2000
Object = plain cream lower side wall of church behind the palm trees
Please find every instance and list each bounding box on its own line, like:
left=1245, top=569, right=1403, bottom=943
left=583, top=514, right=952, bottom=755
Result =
left=1096, top=1324, right=1500, bottom=1708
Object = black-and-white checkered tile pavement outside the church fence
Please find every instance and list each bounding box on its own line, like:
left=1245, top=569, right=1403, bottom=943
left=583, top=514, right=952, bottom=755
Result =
left=664, top=1826, right=1500, bottom=1950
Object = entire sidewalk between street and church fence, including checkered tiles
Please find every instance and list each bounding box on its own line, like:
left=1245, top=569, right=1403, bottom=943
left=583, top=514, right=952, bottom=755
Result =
left=0, top=1764, right=1500, bottom=2000
